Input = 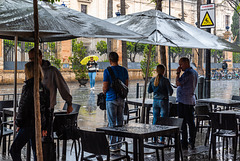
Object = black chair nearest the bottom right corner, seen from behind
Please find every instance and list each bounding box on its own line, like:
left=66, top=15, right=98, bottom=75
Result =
left=209, top=113, right=238, bottom=160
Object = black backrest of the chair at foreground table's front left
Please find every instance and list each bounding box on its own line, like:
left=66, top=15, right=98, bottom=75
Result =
left=80, top=130, right=109, bottom=155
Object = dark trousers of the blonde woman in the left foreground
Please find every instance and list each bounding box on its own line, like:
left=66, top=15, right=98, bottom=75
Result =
left=10, top=127, right=37, bottom=161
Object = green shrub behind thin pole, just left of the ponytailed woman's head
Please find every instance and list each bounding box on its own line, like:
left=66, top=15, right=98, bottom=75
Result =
left=140, top=45, right=157, bottom=78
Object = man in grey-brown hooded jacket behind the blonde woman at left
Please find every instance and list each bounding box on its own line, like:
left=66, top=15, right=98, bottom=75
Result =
left=28, top=48, right=73, bottom=137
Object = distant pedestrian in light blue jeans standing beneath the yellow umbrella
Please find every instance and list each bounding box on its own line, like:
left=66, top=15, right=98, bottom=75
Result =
left=87, top=57, right=98, bottom=90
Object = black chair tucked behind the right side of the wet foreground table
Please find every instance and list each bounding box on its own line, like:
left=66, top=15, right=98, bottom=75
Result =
left=144, top=117, right=183, bottom=161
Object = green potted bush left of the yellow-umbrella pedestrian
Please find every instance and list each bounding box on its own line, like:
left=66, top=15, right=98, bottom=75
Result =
left=69, top=39, right=89, bottom=86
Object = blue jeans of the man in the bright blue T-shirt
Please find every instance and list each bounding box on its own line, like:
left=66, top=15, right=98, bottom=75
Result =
left=106, top=98, right=125, bottom=148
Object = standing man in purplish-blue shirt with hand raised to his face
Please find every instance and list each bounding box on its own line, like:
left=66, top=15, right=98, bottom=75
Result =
left=176, top=57, right=198, bottom=149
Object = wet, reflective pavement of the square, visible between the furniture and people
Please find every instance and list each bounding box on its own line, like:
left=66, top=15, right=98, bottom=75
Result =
left=0, top=80, right=240, bottom=161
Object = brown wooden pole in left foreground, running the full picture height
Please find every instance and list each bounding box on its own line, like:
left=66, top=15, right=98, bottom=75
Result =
left=33, top=0, right=43, bottom=161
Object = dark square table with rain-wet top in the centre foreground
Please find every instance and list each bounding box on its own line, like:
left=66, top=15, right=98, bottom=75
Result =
left=96, top=123, right=180, bottom=161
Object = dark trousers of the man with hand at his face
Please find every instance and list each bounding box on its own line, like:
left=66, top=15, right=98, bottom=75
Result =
left=178, top=103, right=196, bottom=147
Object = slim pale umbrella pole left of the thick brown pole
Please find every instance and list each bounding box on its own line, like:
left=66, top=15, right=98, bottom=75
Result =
left=13, top=36, right=18, bottom=138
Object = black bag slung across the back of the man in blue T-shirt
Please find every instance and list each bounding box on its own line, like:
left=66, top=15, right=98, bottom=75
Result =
left=107, top=67, right=128, bottom=99
